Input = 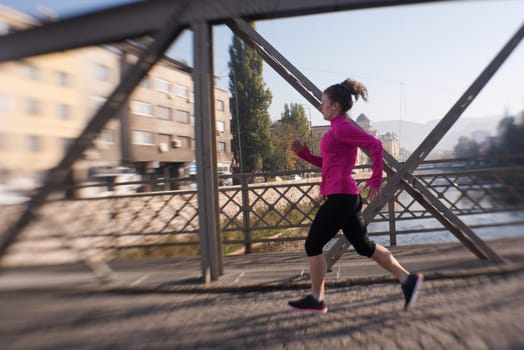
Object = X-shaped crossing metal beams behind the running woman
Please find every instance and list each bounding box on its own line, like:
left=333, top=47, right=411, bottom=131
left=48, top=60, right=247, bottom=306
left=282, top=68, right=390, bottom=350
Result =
left=227, top=18, right=524, bottom=268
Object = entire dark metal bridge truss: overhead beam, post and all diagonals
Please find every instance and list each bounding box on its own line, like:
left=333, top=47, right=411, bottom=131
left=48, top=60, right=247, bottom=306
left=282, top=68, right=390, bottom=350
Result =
left=0, top=0, right=523, bottom=279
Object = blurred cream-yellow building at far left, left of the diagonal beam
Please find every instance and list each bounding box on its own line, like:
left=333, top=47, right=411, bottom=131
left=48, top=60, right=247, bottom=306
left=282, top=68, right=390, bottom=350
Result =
left=0, top=6, right=86, bottom=190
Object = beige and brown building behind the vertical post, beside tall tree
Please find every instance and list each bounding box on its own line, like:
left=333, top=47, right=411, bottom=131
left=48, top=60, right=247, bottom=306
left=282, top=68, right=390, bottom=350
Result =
left=91, top=45, right=232, bottom=189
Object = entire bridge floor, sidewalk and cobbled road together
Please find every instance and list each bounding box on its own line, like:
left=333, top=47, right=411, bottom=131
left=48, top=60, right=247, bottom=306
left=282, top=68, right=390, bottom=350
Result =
left=0, top=237, right=524, bottom=350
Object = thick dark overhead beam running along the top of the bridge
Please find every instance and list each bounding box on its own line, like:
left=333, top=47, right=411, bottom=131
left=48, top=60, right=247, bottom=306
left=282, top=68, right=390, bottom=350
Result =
left=0, top=0, right=444, bottom=62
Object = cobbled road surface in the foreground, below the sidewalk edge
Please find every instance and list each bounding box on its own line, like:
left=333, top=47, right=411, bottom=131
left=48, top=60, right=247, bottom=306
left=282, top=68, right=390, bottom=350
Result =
left=0, top=272, right=524, bottom=350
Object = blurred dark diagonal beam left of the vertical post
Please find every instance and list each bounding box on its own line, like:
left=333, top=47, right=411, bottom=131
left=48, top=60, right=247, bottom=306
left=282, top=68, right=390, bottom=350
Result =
left=0, top=3, right=190, bottom=274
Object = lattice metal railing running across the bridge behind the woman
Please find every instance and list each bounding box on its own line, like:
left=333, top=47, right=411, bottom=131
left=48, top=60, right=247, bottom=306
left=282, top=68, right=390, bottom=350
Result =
left=0, top=157, right=524, bottom=265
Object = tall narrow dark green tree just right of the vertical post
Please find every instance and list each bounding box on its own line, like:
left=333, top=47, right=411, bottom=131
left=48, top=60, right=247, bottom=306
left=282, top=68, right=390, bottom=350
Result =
left=229, top=27, right=272, bottom=172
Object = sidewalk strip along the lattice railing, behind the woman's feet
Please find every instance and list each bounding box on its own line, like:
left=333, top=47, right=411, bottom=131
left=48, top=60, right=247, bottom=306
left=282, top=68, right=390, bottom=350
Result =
left=0, top=236, right=524, bottom=293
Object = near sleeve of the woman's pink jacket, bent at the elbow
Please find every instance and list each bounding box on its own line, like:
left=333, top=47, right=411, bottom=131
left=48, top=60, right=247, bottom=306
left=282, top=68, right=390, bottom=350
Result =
left=334, top=123, right=384, bottom=188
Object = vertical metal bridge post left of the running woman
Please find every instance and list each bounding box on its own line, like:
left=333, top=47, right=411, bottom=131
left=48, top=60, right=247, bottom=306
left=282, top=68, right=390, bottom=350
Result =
left=192, top=21, right=224, bottom=283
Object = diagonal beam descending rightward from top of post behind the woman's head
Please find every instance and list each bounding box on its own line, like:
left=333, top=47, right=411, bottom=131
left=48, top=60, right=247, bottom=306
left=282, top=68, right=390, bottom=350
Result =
left=227, top=18, right=508, bottom=267
